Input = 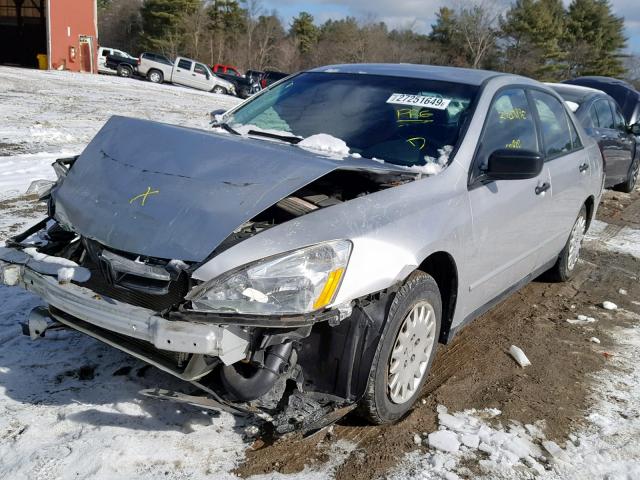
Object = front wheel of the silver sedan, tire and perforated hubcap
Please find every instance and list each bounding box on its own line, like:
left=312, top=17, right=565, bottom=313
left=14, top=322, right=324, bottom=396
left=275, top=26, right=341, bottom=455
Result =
left=358, top=271, right=442, bottom=424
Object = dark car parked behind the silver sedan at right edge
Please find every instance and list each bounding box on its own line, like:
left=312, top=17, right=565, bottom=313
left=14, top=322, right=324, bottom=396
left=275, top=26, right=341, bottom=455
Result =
left=549, top=83, right=640, bottom=193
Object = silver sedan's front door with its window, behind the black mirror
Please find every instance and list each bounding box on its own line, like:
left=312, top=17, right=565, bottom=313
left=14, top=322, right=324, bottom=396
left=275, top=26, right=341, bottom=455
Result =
left=466, top=88, right=550, bottom=310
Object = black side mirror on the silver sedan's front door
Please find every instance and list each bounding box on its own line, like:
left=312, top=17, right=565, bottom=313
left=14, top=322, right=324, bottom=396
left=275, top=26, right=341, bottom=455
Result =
left=484, top=148, right=544, bottom=180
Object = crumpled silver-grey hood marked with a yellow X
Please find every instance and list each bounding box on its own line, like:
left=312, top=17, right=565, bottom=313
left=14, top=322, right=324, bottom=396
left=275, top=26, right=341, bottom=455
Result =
left=52, top=117, right=406, bottom=262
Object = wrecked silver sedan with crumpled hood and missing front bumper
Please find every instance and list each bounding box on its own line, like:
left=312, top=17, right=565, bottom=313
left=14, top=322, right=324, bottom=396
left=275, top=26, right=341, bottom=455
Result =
left=0, top=65, right=603, bottom=432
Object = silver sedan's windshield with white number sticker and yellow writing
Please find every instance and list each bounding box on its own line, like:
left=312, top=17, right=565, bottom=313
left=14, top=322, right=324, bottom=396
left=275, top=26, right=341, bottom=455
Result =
left=225, top=72, right=478, bottom=166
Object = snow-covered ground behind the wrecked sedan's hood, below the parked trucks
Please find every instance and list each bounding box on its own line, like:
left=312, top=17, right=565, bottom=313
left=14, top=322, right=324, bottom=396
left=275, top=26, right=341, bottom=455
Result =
left=0, top=67, right=240, bottom=196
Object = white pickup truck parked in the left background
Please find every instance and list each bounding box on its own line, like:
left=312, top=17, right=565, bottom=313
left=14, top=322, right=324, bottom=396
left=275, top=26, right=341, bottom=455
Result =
left=138, top=53, right=236, bottom=95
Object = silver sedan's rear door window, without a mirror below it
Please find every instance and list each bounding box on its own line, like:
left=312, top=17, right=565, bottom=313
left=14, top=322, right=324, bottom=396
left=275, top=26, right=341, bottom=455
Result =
left=531, top=90, right=577, bottom=158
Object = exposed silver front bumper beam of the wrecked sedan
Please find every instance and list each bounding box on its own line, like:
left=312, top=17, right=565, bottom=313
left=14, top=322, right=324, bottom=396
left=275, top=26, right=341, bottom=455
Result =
left=0, top=260, right=250, bottom=365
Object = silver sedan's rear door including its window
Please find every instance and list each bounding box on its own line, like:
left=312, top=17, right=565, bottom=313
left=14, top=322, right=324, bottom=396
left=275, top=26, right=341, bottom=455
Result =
left=529, top=89, right=591, bottom=266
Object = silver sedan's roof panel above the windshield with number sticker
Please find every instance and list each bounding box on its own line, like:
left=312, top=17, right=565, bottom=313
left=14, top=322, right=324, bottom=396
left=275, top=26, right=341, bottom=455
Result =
left=311, top=63, right=500, bottom=85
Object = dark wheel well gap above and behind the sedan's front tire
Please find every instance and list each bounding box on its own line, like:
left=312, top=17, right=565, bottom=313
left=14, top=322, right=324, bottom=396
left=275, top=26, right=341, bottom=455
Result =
left=418, top=252, right=458, bottom=343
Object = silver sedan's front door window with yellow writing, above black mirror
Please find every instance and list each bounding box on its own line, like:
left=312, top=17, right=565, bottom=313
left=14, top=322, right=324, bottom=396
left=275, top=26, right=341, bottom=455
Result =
left=476, top=88, right=538, bottom=168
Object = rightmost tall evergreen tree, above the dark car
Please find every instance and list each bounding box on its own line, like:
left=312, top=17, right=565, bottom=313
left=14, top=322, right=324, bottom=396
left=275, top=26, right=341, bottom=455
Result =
left=565, top=0, right=627, bottom=77
